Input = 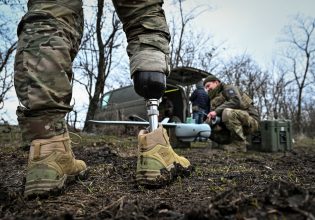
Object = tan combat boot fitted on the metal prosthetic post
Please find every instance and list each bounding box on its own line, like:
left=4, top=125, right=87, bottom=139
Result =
left=136, top=125, right=192, bottom=187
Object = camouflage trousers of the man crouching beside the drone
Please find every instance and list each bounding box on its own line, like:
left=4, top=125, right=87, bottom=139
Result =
left=210, top=108, right=259, bottom=144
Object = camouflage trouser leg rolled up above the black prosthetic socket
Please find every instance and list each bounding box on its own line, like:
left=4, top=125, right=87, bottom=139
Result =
left=113, top=0, right=170, bottom=75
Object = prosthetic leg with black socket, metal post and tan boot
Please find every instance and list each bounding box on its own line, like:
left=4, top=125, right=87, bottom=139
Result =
left=133, top=72, right=192, bottom=187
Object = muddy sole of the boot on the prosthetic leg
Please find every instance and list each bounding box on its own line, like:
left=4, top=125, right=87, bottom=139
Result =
left=136, top=163, right=193, bottom=188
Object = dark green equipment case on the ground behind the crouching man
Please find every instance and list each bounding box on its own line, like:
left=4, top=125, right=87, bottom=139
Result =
left=249, top=120, right=292, bottom=152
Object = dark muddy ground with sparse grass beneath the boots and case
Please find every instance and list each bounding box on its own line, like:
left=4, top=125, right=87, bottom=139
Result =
left=0, top=129, right=315, bottom=220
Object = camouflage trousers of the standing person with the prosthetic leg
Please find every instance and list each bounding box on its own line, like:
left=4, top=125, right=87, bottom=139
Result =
left=14, top=0, right=169, bottom=142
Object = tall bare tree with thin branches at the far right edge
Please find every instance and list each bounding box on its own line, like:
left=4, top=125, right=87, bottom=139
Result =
left=283, top=15, right=315, bottom=133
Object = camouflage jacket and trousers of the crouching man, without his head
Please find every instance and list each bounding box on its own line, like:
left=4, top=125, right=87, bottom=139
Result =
left=209, top=83, right=259, bottom=144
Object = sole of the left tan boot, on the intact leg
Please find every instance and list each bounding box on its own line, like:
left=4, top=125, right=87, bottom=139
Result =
left=24, top=169, right=88, bottom=199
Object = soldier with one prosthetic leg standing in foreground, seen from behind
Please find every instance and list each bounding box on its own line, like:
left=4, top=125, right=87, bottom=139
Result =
left=14, top=0, right=190, bottom=199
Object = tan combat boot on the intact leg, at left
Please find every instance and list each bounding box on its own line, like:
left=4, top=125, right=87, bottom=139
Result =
left=24, top=132, right=87, bottom=197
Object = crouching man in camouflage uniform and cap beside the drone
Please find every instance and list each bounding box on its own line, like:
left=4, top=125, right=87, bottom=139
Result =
left=204, top=75, right=259, bottom=152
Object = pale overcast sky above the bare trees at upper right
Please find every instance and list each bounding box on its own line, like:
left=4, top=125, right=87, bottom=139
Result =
left=164, top=0, right=315, bottom=66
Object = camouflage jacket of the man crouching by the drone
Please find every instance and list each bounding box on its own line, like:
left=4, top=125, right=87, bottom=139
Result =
left=209, top=83, right=259, bottom=121
